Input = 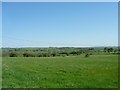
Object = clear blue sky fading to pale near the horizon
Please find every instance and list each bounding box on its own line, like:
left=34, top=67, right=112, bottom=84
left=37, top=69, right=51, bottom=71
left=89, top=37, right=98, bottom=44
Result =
left=2, top=2, right=118, bottom=47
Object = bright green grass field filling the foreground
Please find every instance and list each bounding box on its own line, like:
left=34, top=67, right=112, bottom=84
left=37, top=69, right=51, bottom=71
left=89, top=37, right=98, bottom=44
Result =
left=2, top=55, right=118, bottom=88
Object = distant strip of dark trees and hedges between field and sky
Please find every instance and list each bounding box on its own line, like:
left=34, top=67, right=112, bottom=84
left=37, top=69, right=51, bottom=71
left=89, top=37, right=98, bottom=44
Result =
left=2, top=47, right=120, bottom=57
